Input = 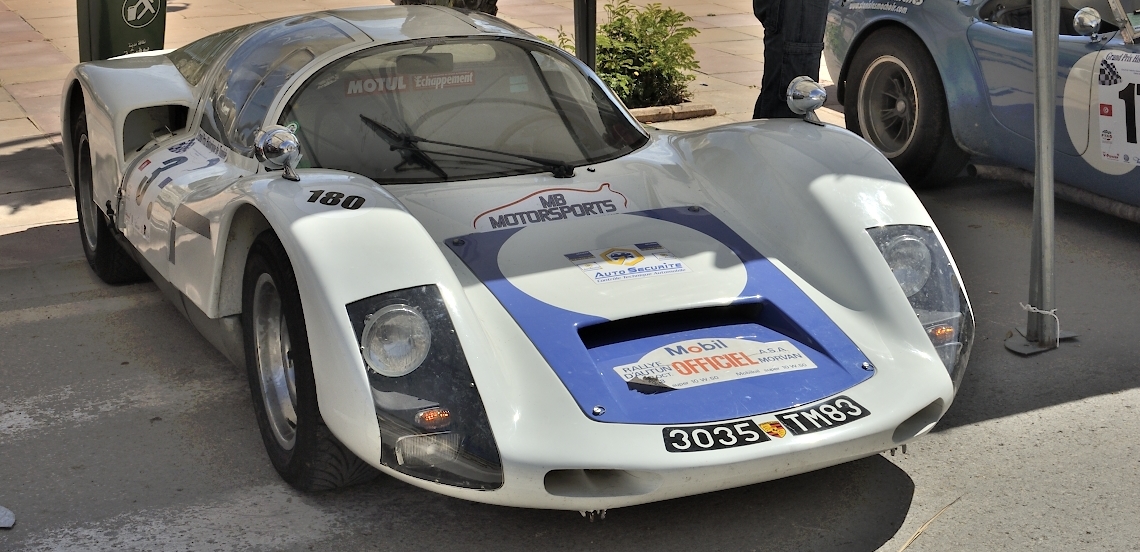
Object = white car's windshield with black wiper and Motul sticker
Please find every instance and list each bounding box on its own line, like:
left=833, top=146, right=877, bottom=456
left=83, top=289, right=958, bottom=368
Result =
left=279, top=39, right=648, bottom=184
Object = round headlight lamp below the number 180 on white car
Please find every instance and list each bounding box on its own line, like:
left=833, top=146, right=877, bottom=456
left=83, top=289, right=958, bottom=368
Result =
left=360, top=305, right=431, bottom=378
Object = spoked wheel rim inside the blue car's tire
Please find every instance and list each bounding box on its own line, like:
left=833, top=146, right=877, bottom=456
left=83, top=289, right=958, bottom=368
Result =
left=858, top=56, right=920, bottom=159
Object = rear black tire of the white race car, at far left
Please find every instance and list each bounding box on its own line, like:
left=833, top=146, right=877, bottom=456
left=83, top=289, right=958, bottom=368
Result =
left=72, top=112, right=146, bottom=284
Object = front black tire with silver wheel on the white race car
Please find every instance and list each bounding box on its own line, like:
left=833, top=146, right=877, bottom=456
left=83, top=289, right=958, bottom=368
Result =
left=242, top=232, right=378, bottom=490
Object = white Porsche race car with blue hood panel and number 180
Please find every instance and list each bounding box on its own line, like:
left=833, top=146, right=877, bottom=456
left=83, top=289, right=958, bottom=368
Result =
left=62, top=6, right=974, bottom=512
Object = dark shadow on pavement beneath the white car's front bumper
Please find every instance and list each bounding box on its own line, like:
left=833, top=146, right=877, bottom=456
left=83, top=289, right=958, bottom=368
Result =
left=316, top=455, right=914, bottom=551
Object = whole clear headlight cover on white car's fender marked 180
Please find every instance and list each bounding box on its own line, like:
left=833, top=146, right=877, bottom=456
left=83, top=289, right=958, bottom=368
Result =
left=345, top=285, right=503, bottom=490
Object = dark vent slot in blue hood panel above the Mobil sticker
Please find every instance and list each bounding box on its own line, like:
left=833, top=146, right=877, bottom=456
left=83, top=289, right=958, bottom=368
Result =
left=578, top=302, right=779, bottom=349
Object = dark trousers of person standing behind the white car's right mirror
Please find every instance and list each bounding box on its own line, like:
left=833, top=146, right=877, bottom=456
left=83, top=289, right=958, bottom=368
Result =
left=752, top=0, right=828, bottom=119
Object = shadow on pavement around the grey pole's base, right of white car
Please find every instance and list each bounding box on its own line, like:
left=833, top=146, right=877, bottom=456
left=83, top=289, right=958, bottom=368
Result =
left=920, top=179, right=1140, bottom=431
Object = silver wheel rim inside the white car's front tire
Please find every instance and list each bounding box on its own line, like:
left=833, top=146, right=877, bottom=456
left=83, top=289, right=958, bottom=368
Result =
left=253, top=274, right=296, bottom=450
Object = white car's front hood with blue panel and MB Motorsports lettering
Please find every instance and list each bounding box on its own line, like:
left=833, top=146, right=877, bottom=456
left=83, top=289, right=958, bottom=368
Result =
left=390, top=167, right=873, bottom=424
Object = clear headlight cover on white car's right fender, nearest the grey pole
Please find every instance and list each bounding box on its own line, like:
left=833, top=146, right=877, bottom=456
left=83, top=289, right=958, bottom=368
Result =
left=866, top=225, right=974, bottom=389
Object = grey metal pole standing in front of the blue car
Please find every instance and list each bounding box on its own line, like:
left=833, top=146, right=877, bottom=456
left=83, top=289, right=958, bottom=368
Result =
left=1025, top=0, right=1060, bottom=349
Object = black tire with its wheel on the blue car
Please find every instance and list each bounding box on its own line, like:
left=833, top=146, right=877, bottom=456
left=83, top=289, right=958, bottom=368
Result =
left=844, top=29, right=970, bottom=188
